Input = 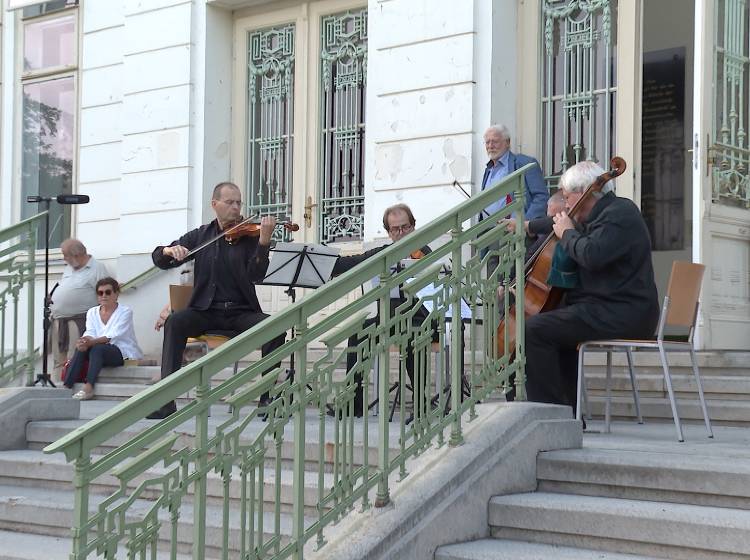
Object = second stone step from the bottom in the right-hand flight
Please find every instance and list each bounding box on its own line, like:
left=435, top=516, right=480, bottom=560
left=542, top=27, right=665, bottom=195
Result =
left=489, top=492, right=750, bottom=560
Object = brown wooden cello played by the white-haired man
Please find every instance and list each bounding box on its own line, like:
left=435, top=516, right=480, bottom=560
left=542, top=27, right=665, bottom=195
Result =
left=497, top=157, right=626, bottom=356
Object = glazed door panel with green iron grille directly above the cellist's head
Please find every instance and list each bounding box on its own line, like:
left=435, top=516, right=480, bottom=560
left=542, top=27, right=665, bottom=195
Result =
left=541, top=0, right=617, bottom=190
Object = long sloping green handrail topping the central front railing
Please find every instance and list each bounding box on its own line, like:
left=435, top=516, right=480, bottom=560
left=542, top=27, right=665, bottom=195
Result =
left=44, top=164, right=534, bottom=461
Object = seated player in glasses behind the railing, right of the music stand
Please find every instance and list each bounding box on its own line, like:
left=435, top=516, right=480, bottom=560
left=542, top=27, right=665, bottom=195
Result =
left=329, top=204, right=431, bottom=417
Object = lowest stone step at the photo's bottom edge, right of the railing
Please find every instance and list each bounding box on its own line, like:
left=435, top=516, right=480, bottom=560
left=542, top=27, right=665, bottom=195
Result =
left=435, top=539, right=668, bottom=560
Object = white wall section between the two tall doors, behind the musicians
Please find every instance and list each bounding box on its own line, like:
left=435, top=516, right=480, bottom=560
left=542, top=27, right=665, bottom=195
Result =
left=365, top=0, right=516, bottom=240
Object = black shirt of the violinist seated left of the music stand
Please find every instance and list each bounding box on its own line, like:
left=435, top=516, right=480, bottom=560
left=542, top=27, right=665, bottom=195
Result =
left=151, top=220, right=269, bottom=313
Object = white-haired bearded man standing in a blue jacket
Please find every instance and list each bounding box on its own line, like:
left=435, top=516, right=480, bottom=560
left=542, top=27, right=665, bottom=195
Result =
left=482, top=124, right=549, bottom=220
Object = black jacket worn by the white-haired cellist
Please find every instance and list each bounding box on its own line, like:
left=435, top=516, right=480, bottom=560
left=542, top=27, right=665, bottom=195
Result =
left=560, top=193, right=659, bottom=338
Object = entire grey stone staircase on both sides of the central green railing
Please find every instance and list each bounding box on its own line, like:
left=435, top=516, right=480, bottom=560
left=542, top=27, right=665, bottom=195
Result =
left=0, top=351, right=750, bottom=560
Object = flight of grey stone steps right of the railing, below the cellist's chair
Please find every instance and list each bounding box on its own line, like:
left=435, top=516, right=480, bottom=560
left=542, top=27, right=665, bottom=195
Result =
left=435, top=423, right=750, bottom=560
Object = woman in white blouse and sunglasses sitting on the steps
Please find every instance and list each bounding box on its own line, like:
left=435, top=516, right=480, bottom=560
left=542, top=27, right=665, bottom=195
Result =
left=65, top=277, right=143, bottom=401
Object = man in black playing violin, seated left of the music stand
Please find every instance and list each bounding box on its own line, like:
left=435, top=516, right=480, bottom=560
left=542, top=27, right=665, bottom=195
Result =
left=148, top=182, right=285, bottom=419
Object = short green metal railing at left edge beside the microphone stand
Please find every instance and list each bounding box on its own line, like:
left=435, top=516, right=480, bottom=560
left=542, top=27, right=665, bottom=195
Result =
left=0, top=212, right=46, bottom=387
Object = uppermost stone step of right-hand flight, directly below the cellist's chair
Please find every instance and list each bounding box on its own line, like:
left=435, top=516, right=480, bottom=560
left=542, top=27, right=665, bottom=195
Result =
left=537, top=448, right=750, bottom=510
